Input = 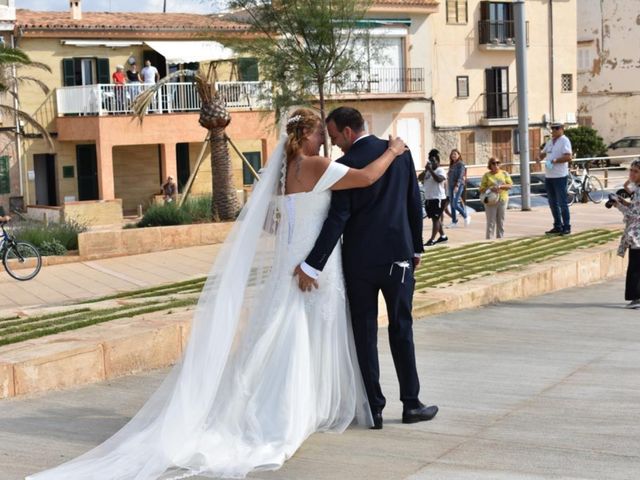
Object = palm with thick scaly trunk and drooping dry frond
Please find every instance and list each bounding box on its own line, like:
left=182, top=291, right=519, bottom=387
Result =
left=132, top=63, right=240, bottom=221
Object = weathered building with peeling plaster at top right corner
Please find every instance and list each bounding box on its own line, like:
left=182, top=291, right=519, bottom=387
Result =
left=577, top=0, right=640, bottom=143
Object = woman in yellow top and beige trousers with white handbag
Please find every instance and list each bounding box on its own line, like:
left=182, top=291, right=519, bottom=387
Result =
left=480, top=158, right=513, bottom=240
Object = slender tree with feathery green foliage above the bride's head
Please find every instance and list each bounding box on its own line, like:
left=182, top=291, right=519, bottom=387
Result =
left=229, top=0, right=372, bottom=155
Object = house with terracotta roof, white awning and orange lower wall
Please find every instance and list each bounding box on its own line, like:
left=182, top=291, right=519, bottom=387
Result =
left=15, top=1, right=277, bottom=218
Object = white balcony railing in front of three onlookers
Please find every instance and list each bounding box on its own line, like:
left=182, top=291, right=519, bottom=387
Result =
left=56, top=82, right=271, bottom=115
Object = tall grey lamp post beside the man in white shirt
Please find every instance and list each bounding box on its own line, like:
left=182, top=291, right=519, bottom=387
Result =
left=513, top=0, right=531, bottom=210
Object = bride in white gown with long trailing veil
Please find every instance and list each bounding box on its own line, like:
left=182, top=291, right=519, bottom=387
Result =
left=27, top=109, right=405, bottom=480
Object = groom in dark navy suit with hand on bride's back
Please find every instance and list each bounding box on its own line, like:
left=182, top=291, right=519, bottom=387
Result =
left=296, top=107, right=438, bottom=429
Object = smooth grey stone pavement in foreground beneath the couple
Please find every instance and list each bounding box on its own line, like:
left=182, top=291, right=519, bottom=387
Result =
left=0, top=280, right=640, bottom=480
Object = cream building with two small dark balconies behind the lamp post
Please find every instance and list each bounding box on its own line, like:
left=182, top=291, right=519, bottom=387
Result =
left=427, top=0, right=577, bottom=171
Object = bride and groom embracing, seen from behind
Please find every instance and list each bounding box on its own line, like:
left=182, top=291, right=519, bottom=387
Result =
left=28, top=107, right=438, bottom=480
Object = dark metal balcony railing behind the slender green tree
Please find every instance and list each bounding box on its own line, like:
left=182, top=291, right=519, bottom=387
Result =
left=329, top=68, right=424, bottom=94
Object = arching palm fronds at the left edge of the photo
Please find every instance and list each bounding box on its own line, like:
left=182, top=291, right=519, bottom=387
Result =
left=0, top=45, right=54, bottom=150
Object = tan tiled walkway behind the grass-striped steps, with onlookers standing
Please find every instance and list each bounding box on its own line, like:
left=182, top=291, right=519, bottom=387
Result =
left=0, top=204, right=621, bottom=316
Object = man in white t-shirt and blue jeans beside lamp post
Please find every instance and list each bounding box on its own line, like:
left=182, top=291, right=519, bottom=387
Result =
left=537, top=123, right=572, bottom=235
